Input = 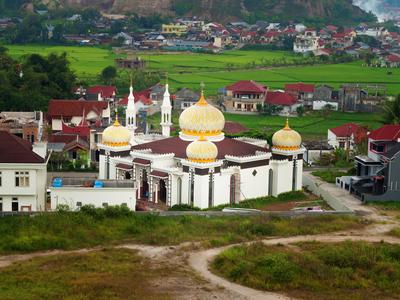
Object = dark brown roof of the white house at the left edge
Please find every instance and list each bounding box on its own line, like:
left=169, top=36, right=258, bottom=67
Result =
left=0, top=131, right=44, bottom=164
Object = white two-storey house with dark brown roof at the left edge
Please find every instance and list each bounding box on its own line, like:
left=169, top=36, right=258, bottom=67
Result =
left=0, top=131, right=47, bottom=211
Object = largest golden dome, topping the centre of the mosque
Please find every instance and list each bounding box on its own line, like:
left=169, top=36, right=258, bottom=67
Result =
left=179, top=92, right=225, bottom=141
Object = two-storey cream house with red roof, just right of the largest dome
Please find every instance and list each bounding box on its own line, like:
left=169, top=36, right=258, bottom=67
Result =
left=224, top=80, right=268, bottom=113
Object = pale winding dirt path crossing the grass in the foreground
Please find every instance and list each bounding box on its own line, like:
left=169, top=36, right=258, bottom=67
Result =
left=0, top=188, right=400, bottom=300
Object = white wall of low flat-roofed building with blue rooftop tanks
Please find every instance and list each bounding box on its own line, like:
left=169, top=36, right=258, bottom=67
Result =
left=50, top=187, right=136, bottom=210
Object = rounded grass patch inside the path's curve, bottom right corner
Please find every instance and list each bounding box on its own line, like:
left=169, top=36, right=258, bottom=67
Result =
left=212, top=242, right=400, bottom=299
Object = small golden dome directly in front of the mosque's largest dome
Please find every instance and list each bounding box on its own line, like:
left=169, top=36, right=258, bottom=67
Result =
left=186, top=136, right=218, bottom=163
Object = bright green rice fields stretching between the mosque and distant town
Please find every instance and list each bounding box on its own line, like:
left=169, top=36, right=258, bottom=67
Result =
left=6, top=45, right=400, bottom=96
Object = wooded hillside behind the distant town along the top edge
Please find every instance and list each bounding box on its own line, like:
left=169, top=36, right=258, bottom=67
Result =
left=0, top=0, right=374, bottom=24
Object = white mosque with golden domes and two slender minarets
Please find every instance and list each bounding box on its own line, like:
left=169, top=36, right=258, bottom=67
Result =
left=98, top=84, right=304, bottom=209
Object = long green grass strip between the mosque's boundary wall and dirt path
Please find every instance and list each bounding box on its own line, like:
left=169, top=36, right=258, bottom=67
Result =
left=0, top=209, right=365, bottom=254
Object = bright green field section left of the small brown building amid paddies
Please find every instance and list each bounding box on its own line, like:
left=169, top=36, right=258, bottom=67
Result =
left=5, top=45, right=122, bottom=78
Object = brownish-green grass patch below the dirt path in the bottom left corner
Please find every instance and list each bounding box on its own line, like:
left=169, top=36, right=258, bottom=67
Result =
left=0, top=249, right=172, bottom=300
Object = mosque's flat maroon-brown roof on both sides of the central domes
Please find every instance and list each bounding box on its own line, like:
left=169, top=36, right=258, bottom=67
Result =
left=132, top=137, right=269, bottom=159
